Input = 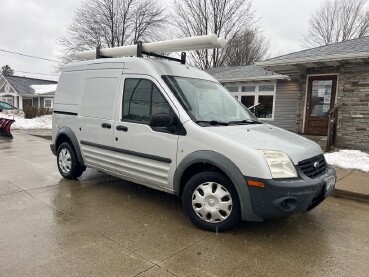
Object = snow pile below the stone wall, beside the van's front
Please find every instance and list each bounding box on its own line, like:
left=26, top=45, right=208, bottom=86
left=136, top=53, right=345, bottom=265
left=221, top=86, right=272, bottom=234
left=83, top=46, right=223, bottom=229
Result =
left=324, top=150, right=369, bottom=172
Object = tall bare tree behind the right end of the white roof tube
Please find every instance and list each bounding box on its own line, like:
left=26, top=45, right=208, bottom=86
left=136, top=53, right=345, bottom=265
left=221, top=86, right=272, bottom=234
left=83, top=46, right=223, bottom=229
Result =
left=173, top=0, right=266, bottom=69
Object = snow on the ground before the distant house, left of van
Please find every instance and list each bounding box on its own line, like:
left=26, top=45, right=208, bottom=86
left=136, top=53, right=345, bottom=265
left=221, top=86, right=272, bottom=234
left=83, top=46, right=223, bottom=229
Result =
left=0, top=111, right=52, bottom=130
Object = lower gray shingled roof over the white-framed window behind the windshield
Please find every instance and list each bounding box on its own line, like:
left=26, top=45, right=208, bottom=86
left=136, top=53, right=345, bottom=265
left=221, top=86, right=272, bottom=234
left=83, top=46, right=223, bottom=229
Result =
left=205, top=65, right=288, bottom=82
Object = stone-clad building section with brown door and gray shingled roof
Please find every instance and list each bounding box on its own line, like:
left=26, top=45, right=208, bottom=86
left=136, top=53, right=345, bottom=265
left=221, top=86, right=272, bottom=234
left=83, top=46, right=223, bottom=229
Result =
left=256, top=36, right=369, bottom=151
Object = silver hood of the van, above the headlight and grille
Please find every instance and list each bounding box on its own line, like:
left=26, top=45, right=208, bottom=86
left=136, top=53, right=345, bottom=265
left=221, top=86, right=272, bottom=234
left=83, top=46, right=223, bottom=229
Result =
left=203, top=123, right=322, bottom=165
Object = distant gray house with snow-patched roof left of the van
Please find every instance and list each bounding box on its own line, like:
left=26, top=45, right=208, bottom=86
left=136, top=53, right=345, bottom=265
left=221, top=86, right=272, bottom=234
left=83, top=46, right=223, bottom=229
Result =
left=0, top=76, right=57, bottom=110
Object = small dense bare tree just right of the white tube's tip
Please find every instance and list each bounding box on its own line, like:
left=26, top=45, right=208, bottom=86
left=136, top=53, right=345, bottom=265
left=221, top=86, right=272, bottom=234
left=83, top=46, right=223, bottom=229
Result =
left=224, top=30, right=269, bottom=66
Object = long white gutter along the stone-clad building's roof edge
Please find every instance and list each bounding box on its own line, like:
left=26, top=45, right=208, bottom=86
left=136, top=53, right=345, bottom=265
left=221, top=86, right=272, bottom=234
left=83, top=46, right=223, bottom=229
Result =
left=255, top=52, right=369, bottom=67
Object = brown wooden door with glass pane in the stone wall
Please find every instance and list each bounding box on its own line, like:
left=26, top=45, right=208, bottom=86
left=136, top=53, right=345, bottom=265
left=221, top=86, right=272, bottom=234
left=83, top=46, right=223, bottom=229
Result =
left=304, top=75, right=337, bottom=135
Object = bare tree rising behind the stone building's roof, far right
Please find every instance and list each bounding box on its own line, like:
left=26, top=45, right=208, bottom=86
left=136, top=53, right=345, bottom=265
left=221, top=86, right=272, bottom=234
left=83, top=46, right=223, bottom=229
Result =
left=302, top=0, right=369, bottom=47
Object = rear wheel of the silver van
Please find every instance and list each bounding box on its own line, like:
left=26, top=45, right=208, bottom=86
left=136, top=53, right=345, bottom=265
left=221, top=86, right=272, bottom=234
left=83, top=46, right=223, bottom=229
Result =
left=56, top=142, right=85, bottom=180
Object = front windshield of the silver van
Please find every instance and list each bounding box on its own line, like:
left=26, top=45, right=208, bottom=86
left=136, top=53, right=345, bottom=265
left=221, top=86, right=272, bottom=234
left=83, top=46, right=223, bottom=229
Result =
left=163, top=76, right=261, bottom=125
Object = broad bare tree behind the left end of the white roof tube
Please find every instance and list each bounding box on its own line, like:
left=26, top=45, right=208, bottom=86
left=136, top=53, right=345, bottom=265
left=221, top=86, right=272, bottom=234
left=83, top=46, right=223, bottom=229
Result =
left=58, top=0, right=166, bottom=66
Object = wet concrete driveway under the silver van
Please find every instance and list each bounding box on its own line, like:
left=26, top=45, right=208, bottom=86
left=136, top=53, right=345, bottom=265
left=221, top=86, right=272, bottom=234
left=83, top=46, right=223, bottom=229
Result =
left=0, top=132, right=369, bottom=276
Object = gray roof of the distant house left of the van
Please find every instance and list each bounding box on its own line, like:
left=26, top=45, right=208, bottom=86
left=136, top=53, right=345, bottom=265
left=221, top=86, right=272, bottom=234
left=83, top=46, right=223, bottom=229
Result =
left=3, top=75, right=57, bottom=95
